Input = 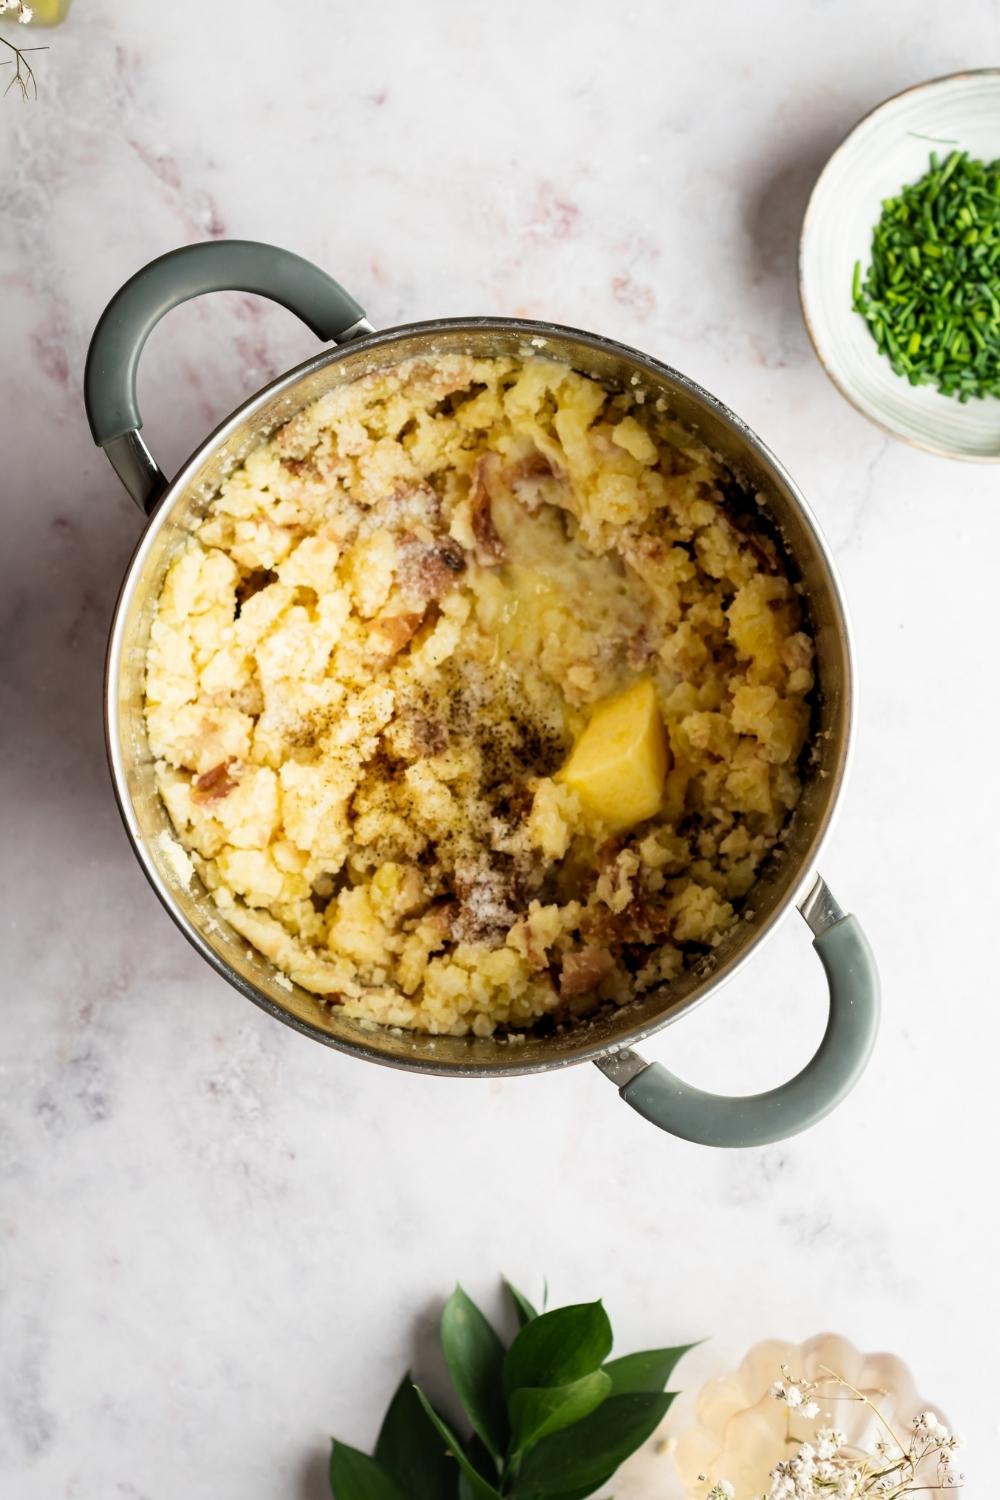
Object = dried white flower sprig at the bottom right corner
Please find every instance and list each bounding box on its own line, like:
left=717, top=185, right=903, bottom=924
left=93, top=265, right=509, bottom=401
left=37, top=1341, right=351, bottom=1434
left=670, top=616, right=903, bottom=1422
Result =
left=706, top=1367, right=964, bottom=1500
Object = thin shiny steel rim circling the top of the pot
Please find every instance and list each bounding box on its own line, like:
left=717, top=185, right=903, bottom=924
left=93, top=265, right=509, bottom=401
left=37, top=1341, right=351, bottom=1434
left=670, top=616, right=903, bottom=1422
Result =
left=103, top=317, right=858, bottom=1079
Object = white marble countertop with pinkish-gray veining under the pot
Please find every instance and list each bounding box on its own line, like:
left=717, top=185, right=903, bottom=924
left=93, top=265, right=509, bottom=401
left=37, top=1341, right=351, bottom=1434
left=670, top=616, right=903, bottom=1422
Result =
left=0, top=0, right=1000, bottom=1500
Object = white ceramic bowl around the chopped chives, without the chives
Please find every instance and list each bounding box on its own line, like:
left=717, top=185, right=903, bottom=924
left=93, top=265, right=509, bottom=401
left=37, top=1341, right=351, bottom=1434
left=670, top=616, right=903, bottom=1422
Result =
left=799, top=68, right=1000, bottom=464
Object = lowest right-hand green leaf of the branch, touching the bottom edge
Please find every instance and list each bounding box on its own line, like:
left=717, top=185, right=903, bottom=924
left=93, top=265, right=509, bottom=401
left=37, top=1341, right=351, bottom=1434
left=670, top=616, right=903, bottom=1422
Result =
left=511, top=1394, right=673, bottom=1500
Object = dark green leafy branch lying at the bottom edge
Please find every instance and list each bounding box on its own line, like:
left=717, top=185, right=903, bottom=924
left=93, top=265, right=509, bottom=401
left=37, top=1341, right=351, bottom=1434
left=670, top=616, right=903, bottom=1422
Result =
left=330, top=1286, right=693, bottom=1500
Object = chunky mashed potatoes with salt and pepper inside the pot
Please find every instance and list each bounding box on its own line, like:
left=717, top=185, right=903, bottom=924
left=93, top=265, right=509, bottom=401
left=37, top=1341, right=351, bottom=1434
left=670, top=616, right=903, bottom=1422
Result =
left=145, top=356, right=813, bottom=1037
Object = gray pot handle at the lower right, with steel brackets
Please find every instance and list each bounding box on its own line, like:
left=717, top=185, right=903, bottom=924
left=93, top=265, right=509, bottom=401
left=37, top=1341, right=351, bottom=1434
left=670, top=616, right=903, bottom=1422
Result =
left=598, top=879, right=879, bottom=1146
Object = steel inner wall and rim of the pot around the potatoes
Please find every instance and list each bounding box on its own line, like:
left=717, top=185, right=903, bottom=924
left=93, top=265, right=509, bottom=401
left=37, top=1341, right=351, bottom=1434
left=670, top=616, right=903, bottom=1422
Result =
left=108, top=320, right=852, bottom=1074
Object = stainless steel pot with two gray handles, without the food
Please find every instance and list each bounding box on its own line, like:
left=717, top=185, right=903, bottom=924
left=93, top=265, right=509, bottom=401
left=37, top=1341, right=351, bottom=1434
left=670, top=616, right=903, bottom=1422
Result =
left=85, top=240, right=879, bottom=1146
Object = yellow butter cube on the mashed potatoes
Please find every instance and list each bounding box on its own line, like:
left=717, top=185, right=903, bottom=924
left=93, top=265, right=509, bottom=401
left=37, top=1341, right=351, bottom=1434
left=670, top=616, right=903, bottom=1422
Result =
left=556, top=677, right=670, bottom=830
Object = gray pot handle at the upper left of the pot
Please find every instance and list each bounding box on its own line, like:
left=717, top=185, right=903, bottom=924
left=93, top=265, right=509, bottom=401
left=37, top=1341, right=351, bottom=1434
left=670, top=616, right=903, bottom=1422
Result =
left=84, top=240, right=372, bottom=515
